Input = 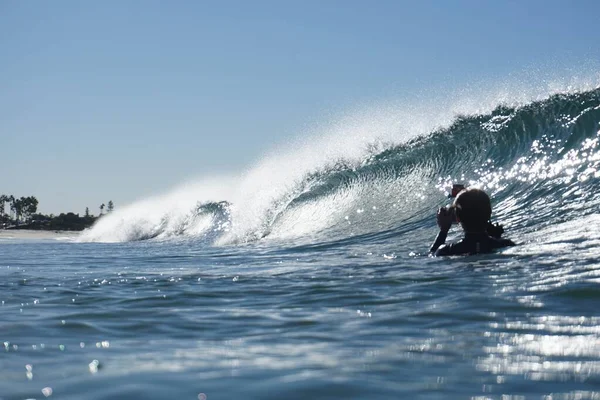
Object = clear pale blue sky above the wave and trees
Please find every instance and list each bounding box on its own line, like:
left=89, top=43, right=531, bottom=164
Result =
left=0, top=0, right=600, bottom=213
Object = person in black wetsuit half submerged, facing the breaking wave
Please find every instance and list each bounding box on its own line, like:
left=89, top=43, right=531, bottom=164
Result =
left=430, top=188, right=515, bottom=256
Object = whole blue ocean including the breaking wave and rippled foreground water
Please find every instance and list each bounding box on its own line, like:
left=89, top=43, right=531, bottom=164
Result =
left=0, top=88, right=600, bottom=400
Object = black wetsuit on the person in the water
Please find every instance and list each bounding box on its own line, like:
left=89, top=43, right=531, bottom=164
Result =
left=429, top=231, right=515, bottom=256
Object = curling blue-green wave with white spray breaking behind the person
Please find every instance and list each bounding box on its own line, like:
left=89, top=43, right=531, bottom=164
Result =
left=80, top=88, right=600, bottom=245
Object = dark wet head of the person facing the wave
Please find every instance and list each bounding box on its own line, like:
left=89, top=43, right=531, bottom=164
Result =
left=453, top=188, right=492, bottom=232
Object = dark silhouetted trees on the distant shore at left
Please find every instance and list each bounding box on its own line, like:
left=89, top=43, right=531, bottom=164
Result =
left=0, top=194, right=115, bottom=231
